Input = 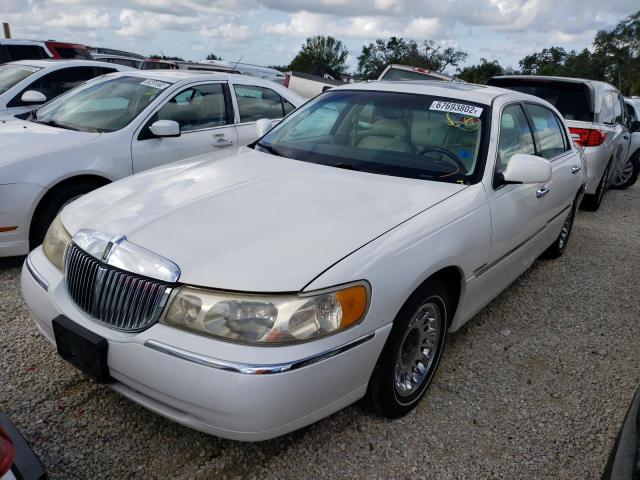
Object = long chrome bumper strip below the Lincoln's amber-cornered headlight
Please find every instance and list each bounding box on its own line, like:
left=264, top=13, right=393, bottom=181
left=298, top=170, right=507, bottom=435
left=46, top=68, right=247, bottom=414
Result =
left=144, top=332, right=376, bottom=375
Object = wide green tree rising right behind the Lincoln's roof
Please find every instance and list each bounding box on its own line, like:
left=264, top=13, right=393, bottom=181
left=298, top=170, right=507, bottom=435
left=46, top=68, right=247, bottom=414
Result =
left=358, top=37, right=467, bottom=80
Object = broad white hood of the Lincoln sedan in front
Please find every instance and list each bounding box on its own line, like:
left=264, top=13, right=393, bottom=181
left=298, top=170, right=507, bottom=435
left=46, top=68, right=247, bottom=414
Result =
left=62, top=148, right=465, bottom=292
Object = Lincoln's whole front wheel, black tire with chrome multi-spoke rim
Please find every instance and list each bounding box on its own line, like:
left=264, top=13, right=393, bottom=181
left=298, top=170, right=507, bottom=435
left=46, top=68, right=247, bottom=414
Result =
left=365, top=280, right=452, bottom=418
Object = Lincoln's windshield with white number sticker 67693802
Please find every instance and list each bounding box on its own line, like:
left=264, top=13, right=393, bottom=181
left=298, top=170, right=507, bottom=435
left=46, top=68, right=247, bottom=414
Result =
left=256, top=91, right=488, bottom=184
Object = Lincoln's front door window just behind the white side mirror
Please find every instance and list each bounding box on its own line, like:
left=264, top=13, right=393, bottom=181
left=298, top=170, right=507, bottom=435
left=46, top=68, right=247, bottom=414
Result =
left=496, top=105, right=536, bottom=173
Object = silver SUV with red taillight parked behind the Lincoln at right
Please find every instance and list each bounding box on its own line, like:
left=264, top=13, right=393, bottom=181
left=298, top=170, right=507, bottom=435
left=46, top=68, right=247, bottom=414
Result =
left=487, top=75, right=630, bottom=211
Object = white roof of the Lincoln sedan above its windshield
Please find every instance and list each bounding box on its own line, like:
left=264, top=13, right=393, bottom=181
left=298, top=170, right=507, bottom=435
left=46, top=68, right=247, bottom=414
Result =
left=331, top=80, right=516, bottom=105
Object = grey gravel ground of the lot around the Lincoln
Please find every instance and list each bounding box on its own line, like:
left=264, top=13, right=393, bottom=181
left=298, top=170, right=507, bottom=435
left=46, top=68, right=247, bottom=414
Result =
left=0, top=184, right=640, bottom=479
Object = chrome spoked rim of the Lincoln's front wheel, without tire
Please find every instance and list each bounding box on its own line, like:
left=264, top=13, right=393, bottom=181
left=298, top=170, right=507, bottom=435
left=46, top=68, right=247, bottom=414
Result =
left=394, top=302, right=442, bottom=397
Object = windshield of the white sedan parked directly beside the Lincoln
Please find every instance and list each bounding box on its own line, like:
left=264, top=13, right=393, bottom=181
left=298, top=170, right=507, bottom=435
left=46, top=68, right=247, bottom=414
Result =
left=34, top=76, right=171, bottom=132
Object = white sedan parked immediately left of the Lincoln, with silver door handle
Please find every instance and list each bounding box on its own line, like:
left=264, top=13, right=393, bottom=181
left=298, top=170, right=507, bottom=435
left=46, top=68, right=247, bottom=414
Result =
left=0, top=67, right=304, bottom=257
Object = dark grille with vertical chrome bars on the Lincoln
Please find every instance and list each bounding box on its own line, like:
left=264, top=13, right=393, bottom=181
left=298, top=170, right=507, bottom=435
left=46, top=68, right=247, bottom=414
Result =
left=65, top=243, right=173, bottom=332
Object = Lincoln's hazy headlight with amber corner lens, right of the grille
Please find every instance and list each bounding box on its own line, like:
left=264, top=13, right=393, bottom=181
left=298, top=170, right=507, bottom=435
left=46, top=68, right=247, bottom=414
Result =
left=161, top=284, right=369, bottom=344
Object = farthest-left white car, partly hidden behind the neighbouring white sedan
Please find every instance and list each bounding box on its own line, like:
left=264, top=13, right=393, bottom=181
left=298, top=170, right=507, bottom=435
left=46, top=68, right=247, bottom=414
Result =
left=0, top=60, right=134, bottom=116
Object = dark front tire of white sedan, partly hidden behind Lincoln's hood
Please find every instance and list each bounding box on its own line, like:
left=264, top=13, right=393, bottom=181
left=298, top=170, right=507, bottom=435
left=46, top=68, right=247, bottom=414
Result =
left=29, top=182, right=101, bottom=250
